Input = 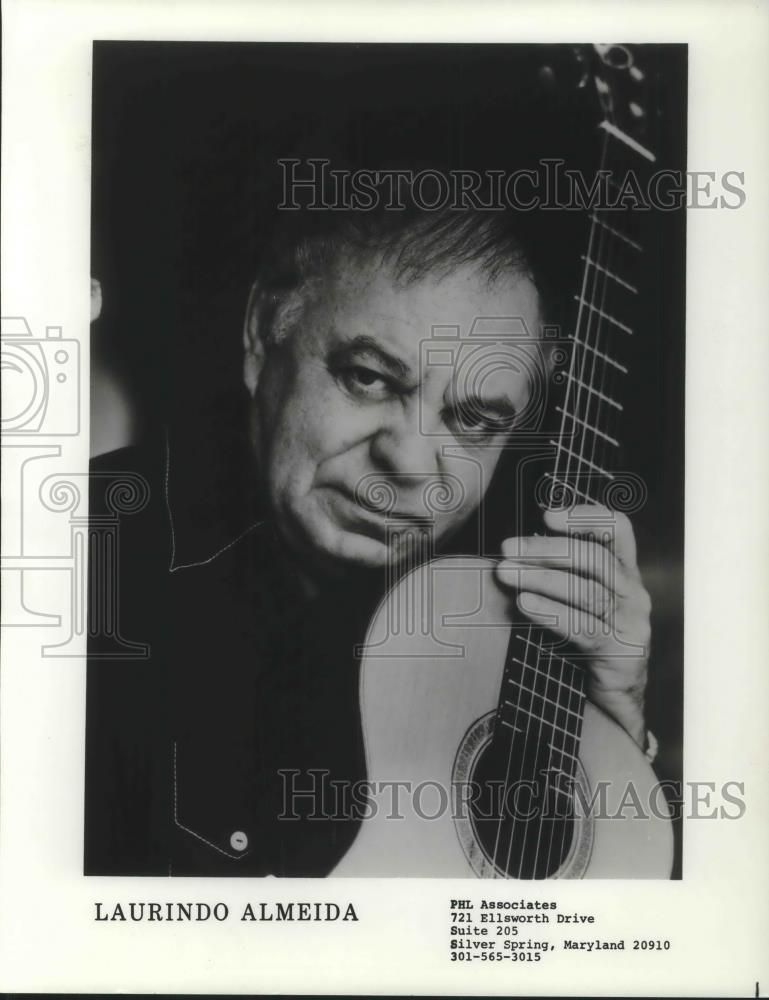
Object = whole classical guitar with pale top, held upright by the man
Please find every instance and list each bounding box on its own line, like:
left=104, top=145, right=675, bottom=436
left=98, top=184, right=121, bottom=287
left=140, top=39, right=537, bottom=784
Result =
left=334, top=46, right=672, bottom=879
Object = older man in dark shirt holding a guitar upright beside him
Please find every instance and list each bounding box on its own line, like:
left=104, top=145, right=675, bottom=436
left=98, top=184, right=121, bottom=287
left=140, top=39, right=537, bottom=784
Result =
left=86, top=205, right=650, bottom=875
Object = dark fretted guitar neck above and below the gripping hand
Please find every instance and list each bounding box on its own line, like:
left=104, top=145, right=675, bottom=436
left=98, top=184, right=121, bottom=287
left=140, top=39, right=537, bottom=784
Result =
left=498, top=109, right=654, bottom=779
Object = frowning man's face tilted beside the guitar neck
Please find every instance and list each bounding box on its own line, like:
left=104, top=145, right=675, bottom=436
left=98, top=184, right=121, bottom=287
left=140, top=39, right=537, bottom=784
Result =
left=246, top=259, right=540, bottom=572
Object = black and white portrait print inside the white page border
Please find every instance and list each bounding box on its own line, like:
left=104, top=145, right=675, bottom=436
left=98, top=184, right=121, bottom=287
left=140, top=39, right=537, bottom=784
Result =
left=84, top=42, right=688, bottom=879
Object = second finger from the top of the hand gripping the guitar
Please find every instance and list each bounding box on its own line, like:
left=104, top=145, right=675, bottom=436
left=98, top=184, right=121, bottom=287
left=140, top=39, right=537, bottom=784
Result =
left=500, top=535, right=631, bottom=597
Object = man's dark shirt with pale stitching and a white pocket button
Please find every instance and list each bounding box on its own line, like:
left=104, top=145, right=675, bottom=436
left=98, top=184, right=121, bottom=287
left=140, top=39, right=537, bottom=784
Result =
left=85, top=438, right=380, bottom=876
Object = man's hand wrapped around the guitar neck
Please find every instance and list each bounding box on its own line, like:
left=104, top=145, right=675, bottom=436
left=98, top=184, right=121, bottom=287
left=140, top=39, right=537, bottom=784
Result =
left=497, top=505, right=651, bottom=746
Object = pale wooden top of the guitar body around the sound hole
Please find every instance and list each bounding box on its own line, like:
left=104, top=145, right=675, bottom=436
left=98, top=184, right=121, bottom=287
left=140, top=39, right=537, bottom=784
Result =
left=333, top=557, right=673, bottom=878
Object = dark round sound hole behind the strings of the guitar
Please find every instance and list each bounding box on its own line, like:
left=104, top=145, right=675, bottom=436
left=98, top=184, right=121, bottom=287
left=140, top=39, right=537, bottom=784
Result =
left=469, top=726, right=574, bottom=879
